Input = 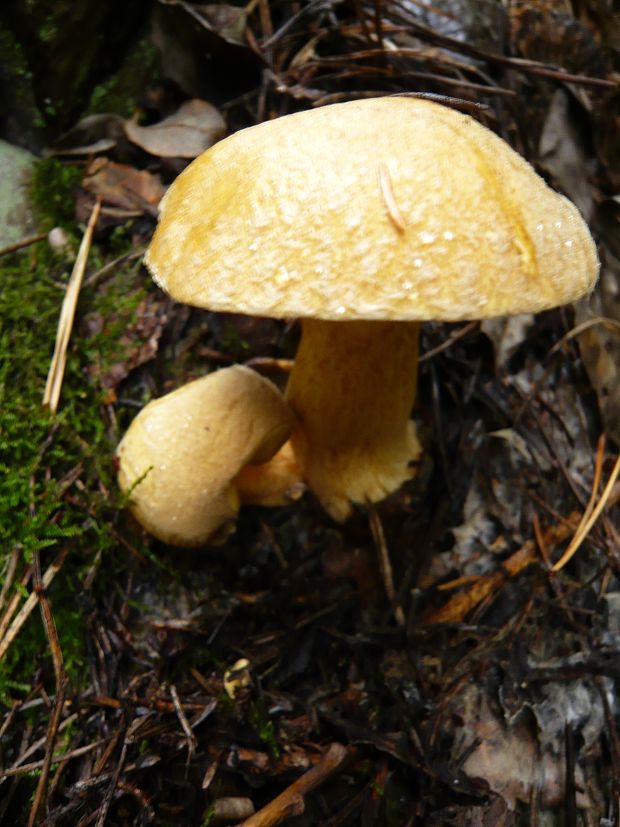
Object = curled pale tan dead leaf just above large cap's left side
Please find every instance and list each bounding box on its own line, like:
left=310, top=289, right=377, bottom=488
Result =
left=125, top=98, right=226, bottom=158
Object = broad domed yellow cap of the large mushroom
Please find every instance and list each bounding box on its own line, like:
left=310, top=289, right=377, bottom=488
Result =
left=146, top=97, right=598, bottom=321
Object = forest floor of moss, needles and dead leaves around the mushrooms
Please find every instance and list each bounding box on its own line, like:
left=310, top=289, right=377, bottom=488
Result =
left=0, top=0, right=620, bottom=827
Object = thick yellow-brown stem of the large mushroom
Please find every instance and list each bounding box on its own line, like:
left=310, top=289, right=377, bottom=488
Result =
left=286, top=319, right=420, bottom=520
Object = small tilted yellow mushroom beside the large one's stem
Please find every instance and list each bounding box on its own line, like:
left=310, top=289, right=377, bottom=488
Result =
left=117, top=365, right=301, bottom=547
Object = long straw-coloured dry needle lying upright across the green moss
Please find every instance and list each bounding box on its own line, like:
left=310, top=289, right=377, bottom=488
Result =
left=43, top=198, right=101, bottom=414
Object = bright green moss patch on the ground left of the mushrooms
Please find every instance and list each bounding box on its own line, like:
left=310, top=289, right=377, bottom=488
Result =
left=0, top=233, right=151, bottom=704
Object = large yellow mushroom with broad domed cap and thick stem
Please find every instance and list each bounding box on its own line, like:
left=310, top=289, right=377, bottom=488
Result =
left=146, top=97, right=598, bottom=519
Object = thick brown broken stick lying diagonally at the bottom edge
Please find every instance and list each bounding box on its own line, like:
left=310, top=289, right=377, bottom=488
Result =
left=237, top=743, right=357, bottom=827
